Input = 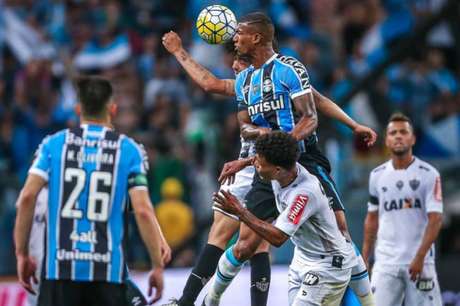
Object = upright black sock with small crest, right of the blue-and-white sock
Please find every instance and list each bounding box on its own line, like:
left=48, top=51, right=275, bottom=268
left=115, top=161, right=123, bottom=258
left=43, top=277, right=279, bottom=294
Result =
left=251, top=252, right=271, bottom=306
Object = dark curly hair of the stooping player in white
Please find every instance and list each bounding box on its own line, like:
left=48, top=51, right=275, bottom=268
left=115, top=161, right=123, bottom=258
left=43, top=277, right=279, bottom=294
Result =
left=256, top=131, right=299, bottom=169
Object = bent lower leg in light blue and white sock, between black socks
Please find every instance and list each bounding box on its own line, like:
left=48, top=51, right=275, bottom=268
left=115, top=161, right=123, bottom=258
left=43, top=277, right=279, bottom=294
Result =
left=204, top=223, right=262, bottom=306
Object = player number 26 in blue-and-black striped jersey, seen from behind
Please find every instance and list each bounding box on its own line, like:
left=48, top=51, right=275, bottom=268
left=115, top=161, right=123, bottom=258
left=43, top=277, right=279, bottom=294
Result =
left=15, top=77, right=169, bottom=306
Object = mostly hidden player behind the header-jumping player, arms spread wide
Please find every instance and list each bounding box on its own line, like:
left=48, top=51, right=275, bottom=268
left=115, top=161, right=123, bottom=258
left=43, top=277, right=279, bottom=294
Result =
left=162, top=26, right=376, bottom=306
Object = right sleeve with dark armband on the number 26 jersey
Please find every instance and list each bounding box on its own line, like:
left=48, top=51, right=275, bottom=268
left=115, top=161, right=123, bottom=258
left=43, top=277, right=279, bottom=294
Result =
left=128, top=141, right=149, bottom=190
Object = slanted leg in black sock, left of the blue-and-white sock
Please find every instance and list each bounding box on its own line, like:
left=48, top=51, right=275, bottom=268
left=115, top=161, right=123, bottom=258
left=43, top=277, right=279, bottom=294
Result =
left=177, top=210, right=240, bottom=306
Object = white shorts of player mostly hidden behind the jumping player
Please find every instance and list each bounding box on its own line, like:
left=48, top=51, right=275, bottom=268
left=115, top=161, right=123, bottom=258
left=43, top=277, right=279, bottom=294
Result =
left=212, top=166, right=255, bottom=220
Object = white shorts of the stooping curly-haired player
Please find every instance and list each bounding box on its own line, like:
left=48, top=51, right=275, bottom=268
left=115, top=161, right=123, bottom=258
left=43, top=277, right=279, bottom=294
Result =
left=288, top=266, right=351, bottom=306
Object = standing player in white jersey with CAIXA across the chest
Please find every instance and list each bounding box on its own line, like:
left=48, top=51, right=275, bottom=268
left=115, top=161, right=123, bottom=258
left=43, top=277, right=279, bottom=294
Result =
left=362, top=114, right=443, bottom=306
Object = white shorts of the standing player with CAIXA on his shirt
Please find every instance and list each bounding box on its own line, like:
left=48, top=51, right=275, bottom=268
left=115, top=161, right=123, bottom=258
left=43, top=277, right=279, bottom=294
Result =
left=371, top=263, right=442, bottom=306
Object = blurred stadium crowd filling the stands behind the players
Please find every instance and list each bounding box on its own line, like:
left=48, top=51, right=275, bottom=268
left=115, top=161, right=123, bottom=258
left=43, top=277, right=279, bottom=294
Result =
left=0, top=0, right=460, bottom=273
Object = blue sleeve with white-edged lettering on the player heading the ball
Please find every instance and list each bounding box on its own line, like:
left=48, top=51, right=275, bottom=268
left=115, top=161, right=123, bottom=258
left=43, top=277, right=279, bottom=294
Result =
left=283, top=59, right=311, bottom=99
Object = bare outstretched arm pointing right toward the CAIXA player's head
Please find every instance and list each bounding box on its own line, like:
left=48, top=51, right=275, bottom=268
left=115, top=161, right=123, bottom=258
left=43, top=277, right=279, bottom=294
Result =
left=312, top=87, right=377, bottom=146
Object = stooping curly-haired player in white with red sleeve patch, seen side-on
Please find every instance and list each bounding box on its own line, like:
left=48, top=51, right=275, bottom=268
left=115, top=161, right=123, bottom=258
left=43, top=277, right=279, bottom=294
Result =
left=214, top=131, right=356, bottom=306
